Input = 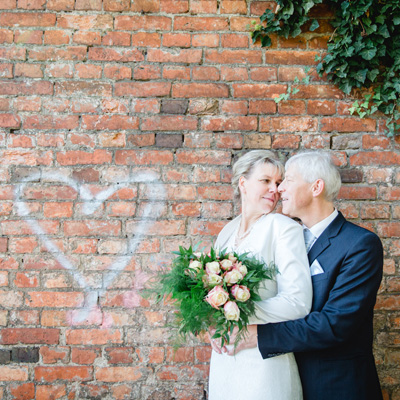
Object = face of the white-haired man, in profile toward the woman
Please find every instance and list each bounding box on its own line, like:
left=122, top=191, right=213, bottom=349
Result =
left=278, top=165, right=313, bottom=219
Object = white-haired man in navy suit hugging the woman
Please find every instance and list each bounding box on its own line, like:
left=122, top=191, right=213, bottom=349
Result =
left=223, top=152, right=383, bottom=400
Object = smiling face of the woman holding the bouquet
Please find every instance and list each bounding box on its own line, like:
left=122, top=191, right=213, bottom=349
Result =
left=239, top=163, right=282, bottom=215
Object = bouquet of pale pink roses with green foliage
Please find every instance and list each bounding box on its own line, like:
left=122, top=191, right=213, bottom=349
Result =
left=157, top=247, right=277, bottom=346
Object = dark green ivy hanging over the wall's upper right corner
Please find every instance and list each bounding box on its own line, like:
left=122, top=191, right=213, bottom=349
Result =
left=252, top=0, right=400, bottom=136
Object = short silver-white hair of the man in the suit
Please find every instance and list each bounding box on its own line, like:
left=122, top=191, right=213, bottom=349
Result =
left=286, top=151, right=342, bottom=201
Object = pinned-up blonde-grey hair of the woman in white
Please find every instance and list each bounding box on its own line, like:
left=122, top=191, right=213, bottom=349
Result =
left=232, top=150, right=285, bottom=197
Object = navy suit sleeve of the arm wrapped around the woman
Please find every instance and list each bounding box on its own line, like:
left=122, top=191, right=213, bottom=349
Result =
left=257, top=232, right=383, bottom=358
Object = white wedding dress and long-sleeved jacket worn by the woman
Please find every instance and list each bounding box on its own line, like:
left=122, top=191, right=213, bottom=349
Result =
left=208, top=213, right=312, bottom=400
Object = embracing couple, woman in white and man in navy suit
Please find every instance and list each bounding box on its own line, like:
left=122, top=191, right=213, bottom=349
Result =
left=209, top=150, right=383, bottom=400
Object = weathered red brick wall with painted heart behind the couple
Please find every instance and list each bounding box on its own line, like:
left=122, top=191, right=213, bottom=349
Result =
left=0, top=0, right=400, bottom=400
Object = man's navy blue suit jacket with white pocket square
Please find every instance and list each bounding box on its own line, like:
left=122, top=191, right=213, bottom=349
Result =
left=258, top=213, right=383, bottom=400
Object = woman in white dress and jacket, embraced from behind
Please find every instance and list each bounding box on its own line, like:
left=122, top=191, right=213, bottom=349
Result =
left=209, top=150, right=312, bottom=400
